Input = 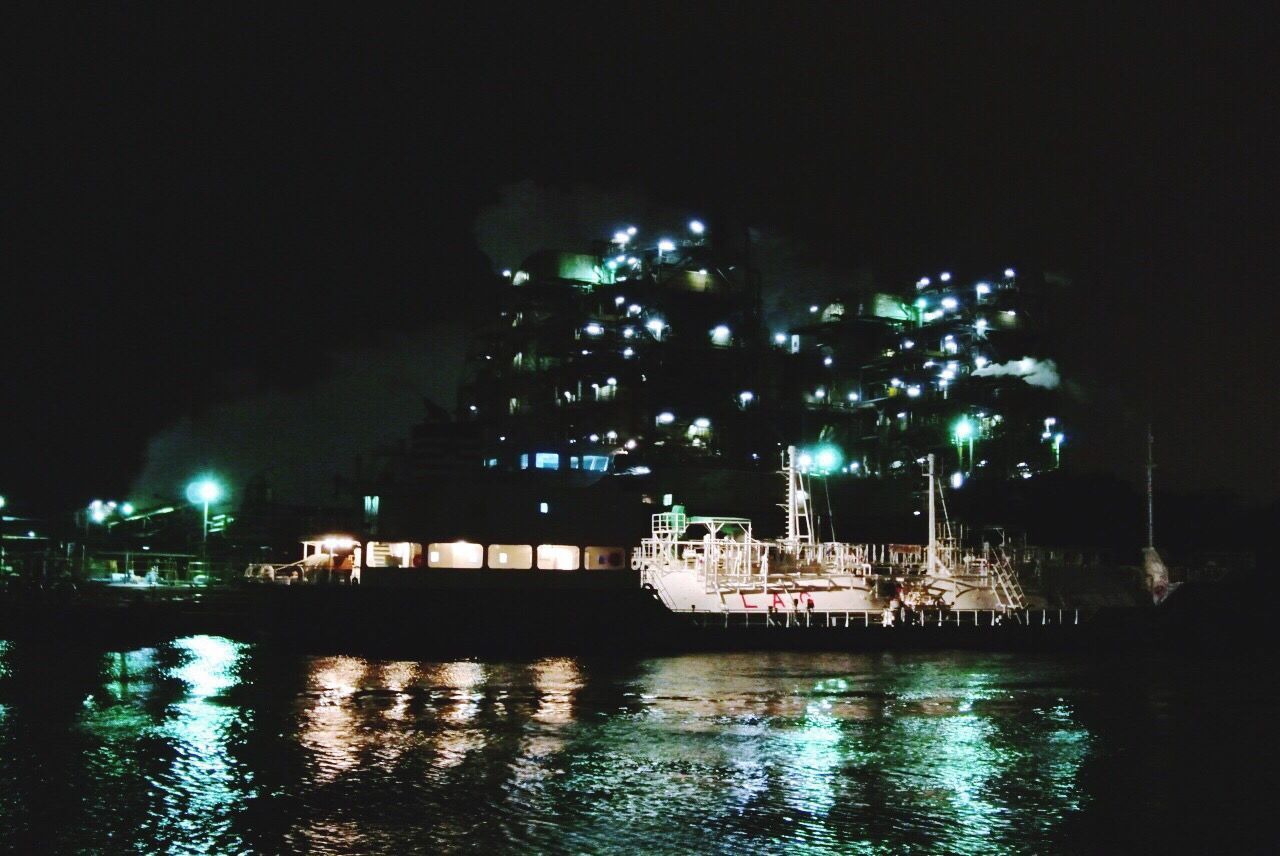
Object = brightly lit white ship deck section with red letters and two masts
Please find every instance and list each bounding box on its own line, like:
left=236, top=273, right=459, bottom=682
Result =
left=632, top=447, right=1025, bottom=626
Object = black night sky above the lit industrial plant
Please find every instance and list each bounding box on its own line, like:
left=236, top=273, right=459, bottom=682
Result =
left=0, top=3, right=1280, bottom=508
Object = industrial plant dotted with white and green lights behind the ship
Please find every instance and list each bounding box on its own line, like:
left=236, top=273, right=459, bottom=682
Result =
left=458, top=221, right=1065, bottom=486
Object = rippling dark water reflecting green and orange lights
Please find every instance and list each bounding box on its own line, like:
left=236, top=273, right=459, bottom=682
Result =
left=0, top=636, right=1275, bottom=853
